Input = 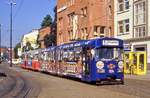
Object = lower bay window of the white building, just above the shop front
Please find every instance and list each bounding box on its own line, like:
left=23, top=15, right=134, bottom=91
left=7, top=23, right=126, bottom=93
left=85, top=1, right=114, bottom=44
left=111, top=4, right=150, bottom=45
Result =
left=134, top=25, right=147, bottom=38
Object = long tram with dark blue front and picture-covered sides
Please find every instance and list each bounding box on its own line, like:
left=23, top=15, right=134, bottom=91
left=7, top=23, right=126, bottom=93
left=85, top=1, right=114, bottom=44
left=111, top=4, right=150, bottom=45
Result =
left=21, top=37, right=124, bottom=84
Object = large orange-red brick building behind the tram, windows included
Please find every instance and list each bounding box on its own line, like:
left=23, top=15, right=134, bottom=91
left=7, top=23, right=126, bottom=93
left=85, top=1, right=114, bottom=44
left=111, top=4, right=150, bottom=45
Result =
left=57, top=0, right=114, bottom=45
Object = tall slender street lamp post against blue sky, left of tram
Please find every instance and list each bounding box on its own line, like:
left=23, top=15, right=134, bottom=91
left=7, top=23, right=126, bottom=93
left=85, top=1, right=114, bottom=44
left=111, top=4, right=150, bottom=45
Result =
left=10, top=1, right=16, bottom=67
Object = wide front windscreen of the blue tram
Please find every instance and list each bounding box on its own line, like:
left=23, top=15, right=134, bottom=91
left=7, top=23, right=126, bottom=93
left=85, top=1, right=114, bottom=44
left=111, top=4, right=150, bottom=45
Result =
left=96, top=48, right=123, bottom=60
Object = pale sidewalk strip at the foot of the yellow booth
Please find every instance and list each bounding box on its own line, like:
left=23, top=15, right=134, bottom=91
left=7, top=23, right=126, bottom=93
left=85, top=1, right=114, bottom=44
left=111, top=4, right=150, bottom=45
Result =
left=125, top=70, right=150, bottom=81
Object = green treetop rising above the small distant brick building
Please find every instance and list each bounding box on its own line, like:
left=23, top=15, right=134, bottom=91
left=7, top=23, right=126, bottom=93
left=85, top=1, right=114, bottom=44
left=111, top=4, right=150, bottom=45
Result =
left=41, top=14, right=53, bottom=28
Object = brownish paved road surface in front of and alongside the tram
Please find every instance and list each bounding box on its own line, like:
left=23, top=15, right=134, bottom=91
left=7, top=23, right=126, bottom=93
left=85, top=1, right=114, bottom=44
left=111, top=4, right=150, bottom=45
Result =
left=0, top=62, right=150, bottom=98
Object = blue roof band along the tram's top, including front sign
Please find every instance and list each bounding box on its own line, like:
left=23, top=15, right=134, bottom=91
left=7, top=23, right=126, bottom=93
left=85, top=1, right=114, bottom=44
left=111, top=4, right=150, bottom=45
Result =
left=41, top=37, right=123, bottom=52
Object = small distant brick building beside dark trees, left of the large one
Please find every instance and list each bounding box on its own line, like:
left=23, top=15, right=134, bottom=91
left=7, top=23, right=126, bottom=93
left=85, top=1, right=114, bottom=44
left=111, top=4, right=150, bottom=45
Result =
left=38, top=27, right=51, bottom=48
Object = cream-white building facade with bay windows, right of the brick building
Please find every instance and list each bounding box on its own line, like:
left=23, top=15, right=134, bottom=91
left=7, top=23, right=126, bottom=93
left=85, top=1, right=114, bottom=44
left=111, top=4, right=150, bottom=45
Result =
left=114, top=0, right=150, bottom=68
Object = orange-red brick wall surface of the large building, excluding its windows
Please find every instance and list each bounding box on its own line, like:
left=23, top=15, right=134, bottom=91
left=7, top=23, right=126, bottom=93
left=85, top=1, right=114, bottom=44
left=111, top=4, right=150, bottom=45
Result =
left=57, top=0, right=114, bottom=45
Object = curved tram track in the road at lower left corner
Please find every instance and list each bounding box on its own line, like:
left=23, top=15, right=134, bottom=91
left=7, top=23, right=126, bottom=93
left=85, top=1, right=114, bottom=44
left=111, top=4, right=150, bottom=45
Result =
left=0, top=63, right=40, bottom=98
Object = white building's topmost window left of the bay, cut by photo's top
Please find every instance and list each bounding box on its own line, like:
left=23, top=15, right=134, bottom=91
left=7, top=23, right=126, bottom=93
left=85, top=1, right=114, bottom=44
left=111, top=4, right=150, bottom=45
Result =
left=118, top=0, right=129, bottom=12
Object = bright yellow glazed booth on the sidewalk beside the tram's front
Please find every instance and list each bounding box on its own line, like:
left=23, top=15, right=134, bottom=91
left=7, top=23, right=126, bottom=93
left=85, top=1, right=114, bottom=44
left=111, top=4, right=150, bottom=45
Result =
left=124, top=51, right=147, bottom=75
